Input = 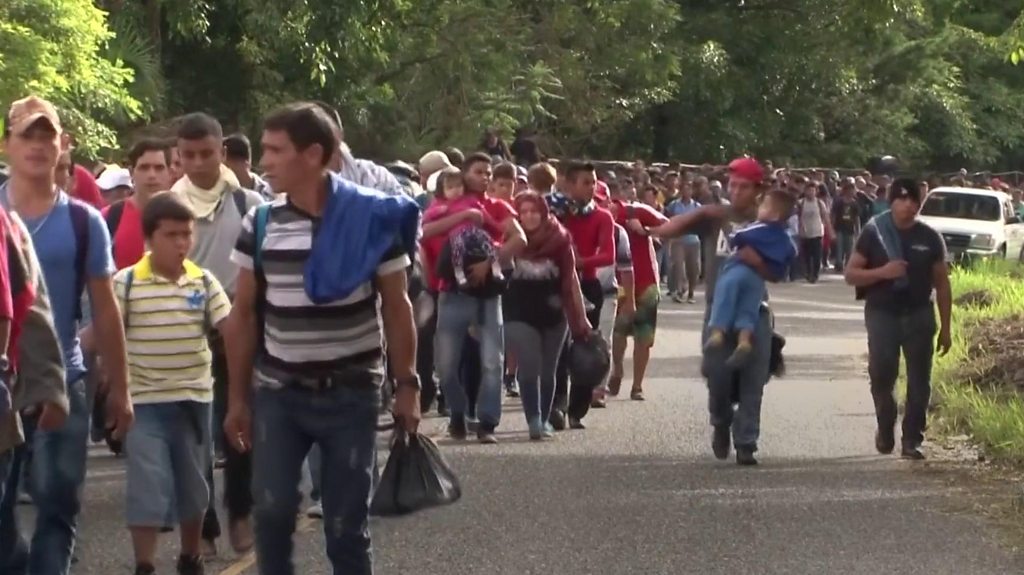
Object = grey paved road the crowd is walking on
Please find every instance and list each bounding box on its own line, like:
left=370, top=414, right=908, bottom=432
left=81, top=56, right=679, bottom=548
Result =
left=23, top=277, right=1024, bottom=575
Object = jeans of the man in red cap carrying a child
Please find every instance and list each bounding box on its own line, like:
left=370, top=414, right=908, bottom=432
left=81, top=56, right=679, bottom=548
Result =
left=703, top=304, right=772, bottom=451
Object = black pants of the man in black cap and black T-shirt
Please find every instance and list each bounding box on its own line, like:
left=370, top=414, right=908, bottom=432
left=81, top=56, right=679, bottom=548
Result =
left=864, top=305, right=936, bottom=447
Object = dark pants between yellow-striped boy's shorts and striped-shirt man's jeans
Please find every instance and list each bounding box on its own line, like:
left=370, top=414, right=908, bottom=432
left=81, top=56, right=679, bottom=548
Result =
left=203, top=342, right=253, bottom=539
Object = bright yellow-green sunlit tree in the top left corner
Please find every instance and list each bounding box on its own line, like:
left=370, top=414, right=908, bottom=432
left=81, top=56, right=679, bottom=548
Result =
left=0, top=0, right=142, bottom=157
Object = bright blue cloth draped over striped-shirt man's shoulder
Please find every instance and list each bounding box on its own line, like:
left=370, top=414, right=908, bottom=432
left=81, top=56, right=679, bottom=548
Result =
left=305, top=174, right=420, bottom=304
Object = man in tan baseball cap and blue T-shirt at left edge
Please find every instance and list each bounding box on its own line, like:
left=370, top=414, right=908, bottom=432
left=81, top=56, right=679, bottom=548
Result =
left=0, top=96, right=134, bottom=573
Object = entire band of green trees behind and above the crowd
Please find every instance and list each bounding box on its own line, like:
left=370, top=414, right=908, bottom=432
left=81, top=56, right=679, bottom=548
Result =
left=0, top=0, right=1024, bottom=171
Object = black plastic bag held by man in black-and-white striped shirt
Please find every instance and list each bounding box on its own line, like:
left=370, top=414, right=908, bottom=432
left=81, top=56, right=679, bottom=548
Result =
left=370, top=431, right=462, bottom=517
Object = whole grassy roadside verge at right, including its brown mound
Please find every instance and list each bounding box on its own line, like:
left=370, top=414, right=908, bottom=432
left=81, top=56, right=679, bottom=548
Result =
left=933, top=262, right=1024, bottom=463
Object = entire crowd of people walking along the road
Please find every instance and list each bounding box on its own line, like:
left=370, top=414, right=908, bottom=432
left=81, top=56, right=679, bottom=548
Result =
left=0, top=91, right=974, bottom=575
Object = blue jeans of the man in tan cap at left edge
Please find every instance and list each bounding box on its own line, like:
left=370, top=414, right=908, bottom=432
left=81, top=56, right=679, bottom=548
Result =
left=0, top=377, right=90, bottom=575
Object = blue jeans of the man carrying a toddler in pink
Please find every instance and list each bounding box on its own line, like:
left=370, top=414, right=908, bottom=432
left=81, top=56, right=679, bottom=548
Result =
left=434, top=292, right=505, bottom=429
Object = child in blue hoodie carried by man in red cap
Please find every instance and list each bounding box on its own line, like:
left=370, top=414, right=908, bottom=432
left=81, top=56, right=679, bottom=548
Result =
left=705, top=189, right=797, bottom=367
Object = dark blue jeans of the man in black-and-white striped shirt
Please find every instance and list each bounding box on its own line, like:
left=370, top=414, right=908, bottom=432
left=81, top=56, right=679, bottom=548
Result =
left=253, top=385, right=380, bottom=575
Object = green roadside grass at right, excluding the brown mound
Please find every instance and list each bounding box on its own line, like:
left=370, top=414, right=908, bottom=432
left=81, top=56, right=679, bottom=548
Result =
left=933, top=262, right=1024, bottom=463
